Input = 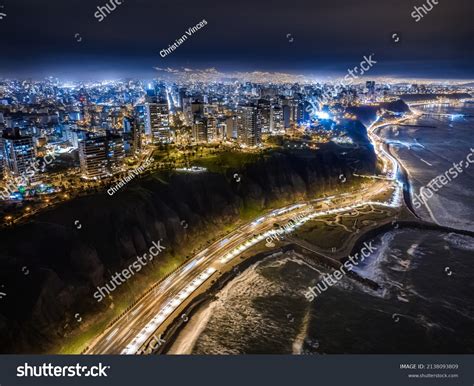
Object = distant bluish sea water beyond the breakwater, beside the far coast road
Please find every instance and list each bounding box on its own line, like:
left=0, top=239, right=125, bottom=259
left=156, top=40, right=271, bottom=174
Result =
left=381, top=103, right=474, bottom=230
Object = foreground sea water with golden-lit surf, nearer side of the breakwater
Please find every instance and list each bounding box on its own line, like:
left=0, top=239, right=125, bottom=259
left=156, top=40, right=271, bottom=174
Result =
left=171, top=229, right=474, bottom=354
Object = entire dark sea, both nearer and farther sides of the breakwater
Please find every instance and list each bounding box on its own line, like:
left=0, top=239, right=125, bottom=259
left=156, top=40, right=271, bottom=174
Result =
left=170, top=105, right=474, bottom=355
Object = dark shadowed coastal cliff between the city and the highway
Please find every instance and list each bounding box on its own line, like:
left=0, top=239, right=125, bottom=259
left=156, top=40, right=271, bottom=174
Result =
left=0, top=143, right=376, bottom=353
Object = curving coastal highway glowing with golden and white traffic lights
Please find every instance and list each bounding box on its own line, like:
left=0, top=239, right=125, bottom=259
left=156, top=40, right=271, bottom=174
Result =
left=85, top=113, right=403, bottom=355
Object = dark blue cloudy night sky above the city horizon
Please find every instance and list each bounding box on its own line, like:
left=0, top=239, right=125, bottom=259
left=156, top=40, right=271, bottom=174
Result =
left=0, top=0, right=474, bottom=79
